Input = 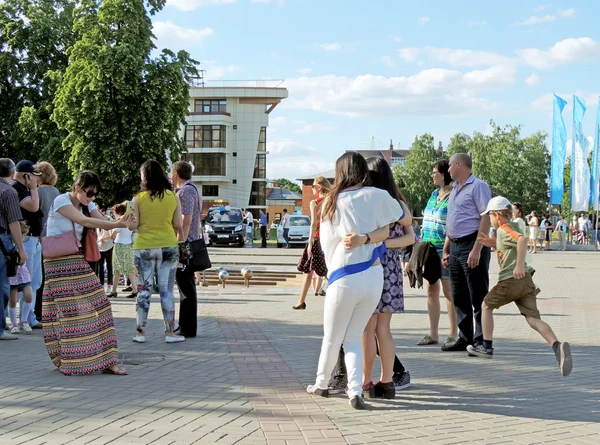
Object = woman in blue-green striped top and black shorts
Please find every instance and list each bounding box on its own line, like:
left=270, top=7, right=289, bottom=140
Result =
left=417, top=159, right=458, bottom=346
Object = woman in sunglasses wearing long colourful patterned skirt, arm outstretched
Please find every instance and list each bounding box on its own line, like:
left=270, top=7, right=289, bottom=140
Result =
left=42, top=171, right=134, bottom=375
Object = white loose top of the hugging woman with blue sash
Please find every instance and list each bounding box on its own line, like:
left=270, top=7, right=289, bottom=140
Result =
left=320, top=187, right=404, bottom=274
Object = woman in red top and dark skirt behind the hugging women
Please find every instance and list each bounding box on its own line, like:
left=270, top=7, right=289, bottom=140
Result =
left=292, top=176, right=331, bottom=309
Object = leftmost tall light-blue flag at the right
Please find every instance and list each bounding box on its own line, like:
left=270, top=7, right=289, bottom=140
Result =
left=550, top=94, right=567, bottom=205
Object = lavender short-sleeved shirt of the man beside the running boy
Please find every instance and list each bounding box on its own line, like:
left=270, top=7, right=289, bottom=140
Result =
left=446, top=174, right=492, bottom=238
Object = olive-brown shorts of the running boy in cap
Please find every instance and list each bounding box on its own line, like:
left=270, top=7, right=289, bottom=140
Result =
left=483, top=274, right=541, bottom=319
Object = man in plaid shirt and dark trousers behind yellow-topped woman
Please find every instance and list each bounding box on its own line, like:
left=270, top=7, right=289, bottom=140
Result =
left=171, top=161, right=202, bottom=338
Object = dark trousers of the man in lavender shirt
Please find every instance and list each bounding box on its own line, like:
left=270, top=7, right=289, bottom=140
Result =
left=448, top=233, right=490, bottom=345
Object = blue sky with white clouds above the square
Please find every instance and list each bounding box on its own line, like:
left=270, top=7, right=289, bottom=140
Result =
left=153, top=0, right=600, bottom=180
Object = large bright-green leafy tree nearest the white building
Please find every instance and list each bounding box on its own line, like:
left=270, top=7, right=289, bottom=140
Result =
left=51, top=0, right=197, bottom=203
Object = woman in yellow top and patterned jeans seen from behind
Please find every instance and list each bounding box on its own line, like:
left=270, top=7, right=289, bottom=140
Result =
left=130, top=160, right=185, bottom=343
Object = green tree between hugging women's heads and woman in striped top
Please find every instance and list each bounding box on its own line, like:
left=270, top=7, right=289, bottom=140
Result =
left=394, top=133, right=437, bottom=217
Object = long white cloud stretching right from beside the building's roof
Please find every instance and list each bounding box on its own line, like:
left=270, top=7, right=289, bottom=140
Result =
left=282, top=65, right=516, bottom=117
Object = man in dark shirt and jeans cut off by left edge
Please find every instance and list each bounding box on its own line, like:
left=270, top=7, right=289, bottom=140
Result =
left=0, top=158, right=27, bottom=340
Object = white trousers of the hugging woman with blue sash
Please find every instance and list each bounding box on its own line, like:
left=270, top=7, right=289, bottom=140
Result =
left=315, top=266, right=383, bottom=398
